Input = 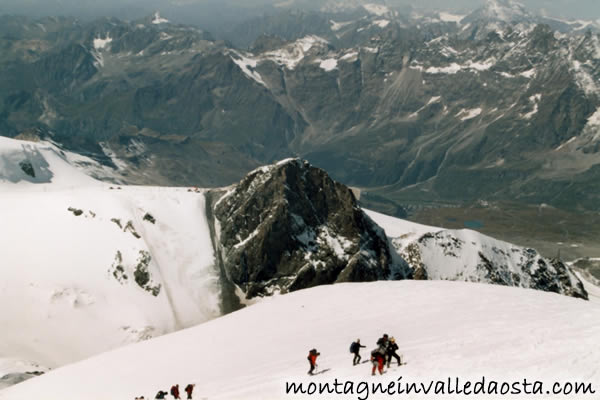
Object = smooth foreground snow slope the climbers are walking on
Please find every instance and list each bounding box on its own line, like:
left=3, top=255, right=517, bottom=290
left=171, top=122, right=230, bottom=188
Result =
left=0, top=281, right=600, bottom=400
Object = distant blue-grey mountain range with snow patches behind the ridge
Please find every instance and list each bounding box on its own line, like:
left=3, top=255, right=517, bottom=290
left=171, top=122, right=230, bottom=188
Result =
left=0, top=0, right=600, bottom=215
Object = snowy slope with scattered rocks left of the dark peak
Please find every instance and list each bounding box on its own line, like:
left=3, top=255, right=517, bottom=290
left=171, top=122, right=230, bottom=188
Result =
left=0, top=138, right=220, bottom=377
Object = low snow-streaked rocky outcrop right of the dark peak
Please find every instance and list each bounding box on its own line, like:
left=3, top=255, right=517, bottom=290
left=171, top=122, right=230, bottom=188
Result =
left=394, top=230, right=588, bottom=299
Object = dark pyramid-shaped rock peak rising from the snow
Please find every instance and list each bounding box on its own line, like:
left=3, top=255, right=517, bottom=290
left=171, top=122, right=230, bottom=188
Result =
left=214, top=159, right=402, bottom=298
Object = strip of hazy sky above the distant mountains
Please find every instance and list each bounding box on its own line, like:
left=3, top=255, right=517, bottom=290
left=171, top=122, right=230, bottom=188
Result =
left=0, top=0, right=600, bottom=20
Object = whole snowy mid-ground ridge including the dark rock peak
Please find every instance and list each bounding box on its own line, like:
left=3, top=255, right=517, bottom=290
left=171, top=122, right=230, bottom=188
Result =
left=0, top=138, right=587, bottom=385
